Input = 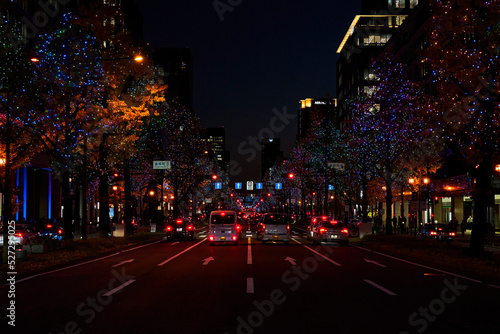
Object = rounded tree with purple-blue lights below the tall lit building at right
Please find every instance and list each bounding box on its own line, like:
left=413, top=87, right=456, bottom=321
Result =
left=356, top=57, right=436, bottom=234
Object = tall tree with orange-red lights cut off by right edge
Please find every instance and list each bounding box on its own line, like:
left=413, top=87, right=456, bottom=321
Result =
left=424, top=0, right=500, bottom=255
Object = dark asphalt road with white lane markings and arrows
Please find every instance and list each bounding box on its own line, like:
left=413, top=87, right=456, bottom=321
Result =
left=0, top=227, right=500, bottom=334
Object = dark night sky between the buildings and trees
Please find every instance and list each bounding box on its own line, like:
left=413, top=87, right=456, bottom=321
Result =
left=137, top=0, right=361, bottom=182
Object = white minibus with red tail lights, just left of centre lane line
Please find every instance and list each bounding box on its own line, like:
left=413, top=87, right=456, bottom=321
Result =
left=208, top=210, right=241, bottom=246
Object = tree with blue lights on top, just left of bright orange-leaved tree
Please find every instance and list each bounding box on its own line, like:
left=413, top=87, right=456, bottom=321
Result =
left=24, top=14, right=104, bottom=239
